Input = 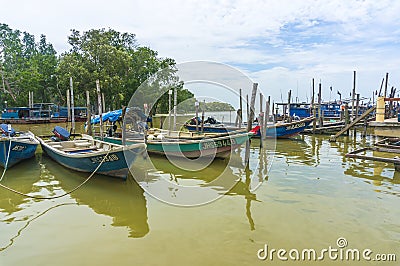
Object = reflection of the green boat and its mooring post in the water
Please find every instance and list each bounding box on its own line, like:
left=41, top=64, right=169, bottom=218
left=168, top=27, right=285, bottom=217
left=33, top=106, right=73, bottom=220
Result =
left=133, top=151, right=257, bottom=230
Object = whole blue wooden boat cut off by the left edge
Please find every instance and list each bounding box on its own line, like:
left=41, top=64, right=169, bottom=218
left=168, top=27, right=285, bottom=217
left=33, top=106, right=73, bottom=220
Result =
left=0, top=124, right=39, bottom=168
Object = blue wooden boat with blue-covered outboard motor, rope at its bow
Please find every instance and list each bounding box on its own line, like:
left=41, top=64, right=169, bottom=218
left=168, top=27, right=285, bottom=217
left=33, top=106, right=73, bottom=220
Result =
left=37, top=126, right=145, bottom=179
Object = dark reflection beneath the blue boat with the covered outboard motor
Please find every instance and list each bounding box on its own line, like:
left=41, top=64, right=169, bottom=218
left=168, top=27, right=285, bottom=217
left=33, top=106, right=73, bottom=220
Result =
left=41, top=156, right=149, bottom=238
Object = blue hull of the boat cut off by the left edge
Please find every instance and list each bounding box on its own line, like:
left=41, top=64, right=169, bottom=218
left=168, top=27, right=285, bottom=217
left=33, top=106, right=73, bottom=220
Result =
left=0, top=133, right=39, bottom=168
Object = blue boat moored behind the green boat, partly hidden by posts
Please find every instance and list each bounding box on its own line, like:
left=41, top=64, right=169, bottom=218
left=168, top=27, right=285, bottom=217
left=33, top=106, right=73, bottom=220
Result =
left=185, top=117, right=314, bottom=138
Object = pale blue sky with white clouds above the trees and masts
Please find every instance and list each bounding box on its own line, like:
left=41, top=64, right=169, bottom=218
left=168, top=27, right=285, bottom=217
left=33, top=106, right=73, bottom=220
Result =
left=0, top=0, right=400, bottom=106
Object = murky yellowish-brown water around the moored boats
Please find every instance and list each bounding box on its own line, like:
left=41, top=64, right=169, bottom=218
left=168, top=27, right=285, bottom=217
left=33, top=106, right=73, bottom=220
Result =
left=0, top=122, right=400, bottom=266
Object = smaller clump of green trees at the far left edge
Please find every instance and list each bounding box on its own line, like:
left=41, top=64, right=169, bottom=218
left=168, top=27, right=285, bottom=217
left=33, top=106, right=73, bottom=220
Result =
left=0, top=24, right=57, bottom=105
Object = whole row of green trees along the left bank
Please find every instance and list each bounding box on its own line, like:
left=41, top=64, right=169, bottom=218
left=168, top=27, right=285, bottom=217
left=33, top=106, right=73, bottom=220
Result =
left=0, top=24, right=193, bottom=112
